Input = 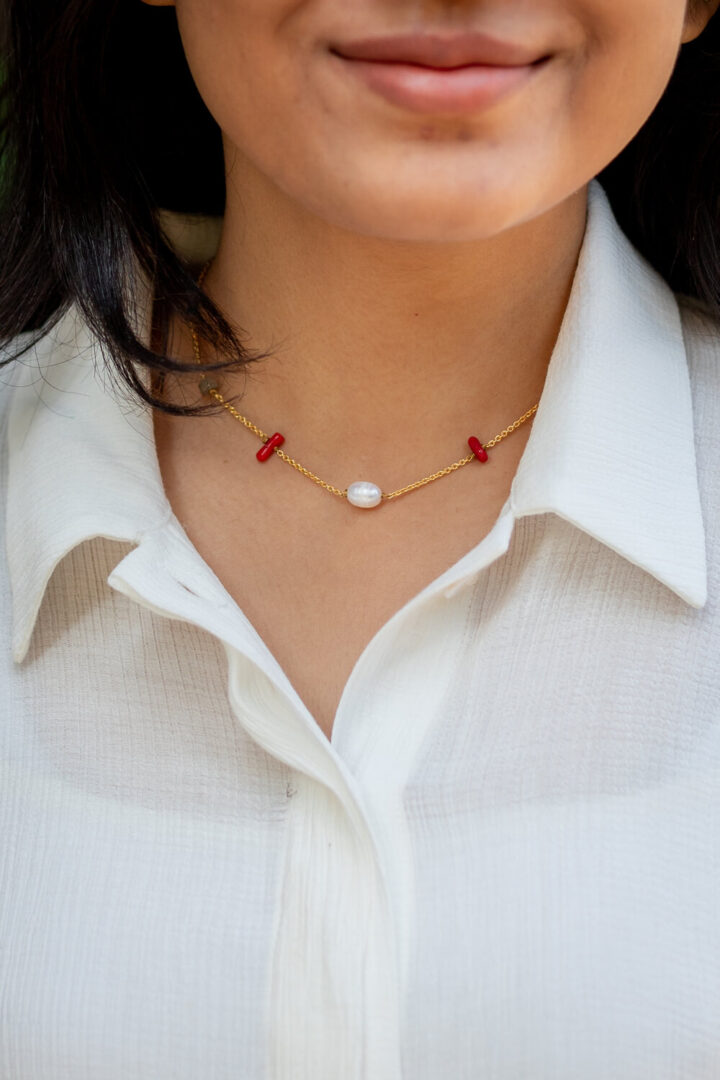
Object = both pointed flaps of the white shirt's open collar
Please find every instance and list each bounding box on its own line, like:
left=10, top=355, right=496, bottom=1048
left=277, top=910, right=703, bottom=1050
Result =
left=6, top=183, right=706, bottom=661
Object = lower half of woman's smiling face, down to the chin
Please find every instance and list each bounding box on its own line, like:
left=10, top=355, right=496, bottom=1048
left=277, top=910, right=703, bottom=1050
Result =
left=149, top=0, right=717, bottom=242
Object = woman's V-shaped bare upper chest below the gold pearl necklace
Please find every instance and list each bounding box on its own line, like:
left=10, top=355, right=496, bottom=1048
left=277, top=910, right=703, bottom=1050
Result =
left=155, top=416, right=528, bottom=739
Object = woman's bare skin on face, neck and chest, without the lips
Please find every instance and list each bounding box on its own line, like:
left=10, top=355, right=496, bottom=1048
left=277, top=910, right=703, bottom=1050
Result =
left=146, top=0, right=719, bottom=738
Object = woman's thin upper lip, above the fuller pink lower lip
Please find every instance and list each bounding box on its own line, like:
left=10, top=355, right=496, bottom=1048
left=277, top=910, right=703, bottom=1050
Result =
left=332, top=32, right=543, bottom=69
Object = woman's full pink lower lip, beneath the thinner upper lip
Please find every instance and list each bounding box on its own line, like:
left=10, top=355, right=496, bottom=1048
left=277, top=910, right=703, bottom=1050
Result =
left=340, top=57, right=540, bottom=116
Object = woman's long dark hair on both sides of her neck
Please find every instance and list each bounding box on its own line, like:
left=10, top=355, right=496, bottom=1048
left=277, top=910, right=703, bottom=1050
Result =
left=0, top=0, right=720, bottom=411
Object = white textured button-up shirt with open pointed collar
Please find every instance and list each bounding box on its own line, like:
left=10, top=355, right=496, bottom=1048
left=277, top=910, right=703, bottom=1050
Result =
left=0, top=185, right=720, bottom=1080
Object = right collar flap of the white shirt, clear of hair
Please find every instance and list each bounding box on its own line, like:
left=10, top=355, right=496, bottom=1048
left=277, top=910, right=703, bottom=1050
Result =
left=511, top=184, right=707, bottom=607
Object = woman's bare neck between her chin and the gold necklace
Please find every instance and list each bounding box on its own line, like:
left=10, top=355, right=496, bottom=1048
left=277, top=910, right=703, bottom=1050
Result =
left=195, top=163, right=586, bottom=465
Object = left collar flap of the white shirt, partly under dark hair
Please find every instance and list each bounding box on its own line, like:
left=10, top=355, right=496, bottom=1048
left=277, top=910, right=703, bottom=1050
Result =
left=5, top=270, right=172, bottom=661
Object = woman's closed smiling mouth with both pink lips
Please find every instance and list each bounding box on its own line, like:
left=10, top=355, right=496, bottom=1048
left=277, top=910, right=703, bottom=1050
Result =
left=330, top=33, right=549, bottom=116
